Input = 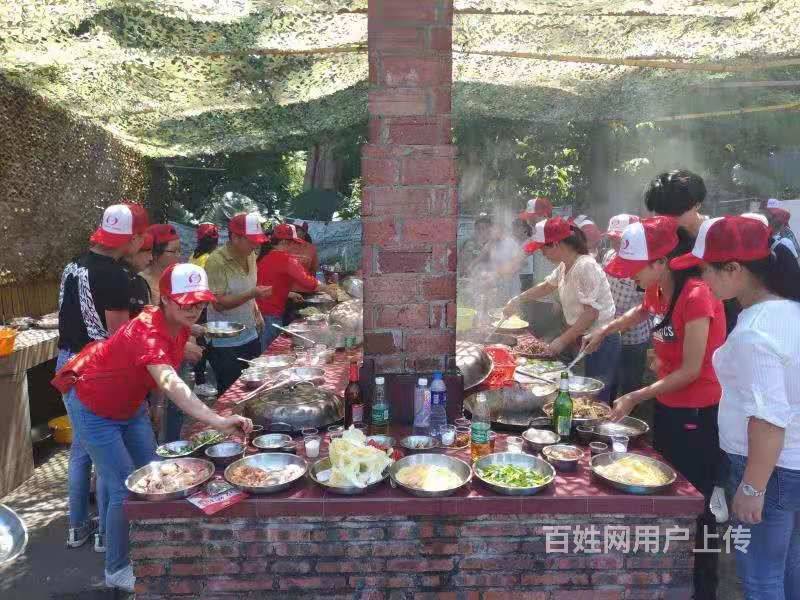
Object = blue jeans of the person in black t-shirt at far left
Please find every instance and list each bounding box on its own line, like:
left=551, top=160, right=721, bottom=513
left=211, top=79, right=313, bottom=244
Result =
left=56, top=350, right=108, bottom=532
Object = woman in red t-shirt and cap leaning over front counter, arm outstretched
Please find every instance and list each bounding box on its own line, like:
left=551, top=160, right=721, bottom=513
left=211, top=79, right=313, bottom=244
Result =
left=52, top=264, right=253, bottom=592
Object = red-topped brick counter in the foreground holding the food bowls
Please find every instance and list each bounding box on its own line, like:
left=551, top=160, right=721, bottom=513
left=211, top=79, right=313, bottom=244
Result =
left=126, top=330, right=703, bottom=599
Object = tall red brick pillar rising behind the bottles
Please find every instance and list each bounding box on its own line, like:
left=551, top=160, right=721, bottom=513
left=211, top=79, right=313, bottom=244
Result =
left=361, top=0, right=458, bottom=373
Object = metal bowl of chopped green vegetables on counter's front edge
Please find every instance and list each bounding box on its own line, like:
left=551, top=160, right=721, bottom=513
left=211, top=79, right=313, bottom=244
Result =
left=472, top=452, right=556, bottom=496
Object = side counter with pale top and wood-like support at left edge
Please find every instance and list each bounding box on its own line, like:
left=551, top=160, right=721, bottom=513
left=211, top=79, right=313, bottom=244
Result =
left=0, top=329, right=58, bottom=497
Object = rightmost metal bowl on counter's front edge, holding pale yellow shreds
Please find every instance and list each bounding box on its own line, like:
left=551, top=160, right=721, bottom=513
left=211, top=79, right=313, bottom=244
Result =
left=590, top=452, right=678, bottom=495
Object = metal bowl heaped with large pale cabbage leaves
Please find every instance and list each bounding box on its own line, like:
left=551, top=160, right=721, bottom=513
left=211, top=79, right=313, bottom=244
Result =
left=308, top=427, right=393, bottom=496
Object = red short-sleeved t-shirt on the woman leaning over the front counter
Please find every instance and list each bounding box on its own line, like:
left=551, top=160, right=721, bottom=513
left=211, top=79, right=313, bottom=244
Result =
left=65, top=306, right=190, bottom=420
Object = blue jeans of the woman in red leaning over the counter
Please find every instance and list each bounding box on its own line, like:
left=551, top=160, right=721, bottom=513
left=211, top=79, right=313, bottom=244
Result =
left=67, top=388, right=158, bottom=573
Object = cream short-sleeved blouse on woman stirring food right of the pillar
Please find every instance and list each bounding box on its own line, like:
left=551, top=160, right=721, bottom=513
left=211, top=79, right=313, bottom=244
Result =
left=546, top=255, right=615, bottom=331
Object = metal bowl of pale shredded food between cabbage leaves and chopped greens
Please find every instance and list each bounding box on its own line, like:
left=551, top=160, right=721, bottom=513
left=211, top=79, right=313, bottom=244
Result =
left=389, top=454, right=472, bottom=498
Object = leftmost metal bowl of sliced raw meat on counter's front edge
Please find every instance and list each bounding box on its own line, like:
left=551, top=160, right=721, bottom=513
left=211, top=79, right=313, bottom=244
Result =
left=125, top=458, right=214, bottom=501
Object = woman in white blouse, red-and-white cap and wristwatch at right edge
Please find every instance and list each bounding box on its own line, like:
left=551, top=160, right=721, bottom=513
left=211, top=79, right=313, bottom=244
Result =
left=671, top=217, right=800, bottom=600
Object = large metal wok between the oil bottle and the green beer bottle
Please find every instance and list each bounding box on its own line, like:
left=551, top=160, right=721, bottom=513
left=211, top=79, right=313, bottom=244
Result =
left=464, top=382, right=558, bottom=429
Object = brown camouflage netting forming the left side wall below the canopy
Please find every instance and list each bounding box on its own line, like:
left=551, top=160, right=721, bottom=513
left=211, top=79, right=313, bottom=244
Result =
left=0, top=77, right=153, bottom=286
